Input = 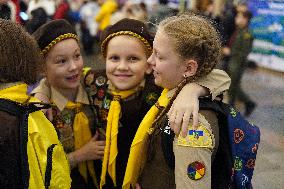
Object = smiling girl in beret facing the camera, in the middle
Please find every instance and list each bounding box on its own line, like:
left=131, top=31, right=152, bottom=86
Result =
left=85, top=19, right=228, bottom=188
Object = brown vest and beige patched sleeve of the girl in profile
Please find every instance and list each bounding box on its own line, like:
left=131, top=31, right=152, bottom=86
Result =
left=138, top=90, right=219, bottom=189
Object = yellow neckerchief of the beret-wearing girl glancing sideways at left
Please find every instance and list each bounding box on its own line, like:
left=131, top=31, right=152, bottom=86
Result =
left=66, top=101, right=98, bottom=187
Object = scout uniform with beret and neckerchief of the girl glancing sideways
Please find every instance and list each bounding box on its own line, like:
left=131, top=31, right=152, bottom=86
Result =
left=32, top=20, right=98, bottom=189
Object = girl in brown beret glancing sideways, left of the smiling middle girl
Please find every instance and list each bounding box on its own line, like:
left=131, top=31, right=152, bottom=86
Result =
left=32, top=20, right=105, bottom=189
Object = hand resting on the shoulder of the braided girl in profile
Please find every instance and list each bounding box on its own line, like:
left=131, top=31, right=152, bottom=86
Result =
left=168, top=83, right=209, bottom=137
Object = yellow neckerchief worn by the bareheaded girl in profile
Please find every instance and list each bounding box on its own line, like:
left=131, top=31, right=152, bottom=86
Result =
left=122, top=89, right=169, bottom=189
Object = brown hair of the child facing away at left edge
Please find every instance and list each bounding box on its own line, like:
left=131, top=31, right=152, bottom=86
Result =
left=0, top=19, right=43, bottom=84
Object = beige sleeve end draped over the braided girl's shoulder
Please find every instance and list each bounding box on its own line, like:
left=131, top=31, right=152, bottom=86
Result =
left=196, top=69, right=231, bottom=100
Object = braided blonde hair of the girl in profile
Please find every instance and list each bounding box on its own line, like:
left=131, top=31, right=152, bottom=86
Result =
left=158, top=13, right=221, bottom=80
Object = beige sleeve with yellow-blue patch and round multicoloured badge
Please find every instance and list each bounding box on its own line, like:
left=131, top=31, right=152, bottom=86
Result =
left=173, top=110, right=217, bottom=189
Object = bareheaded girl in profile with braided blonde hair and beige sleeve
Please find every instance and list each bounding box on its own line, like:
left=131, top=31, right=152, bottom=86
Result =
left=138, top=15, right=231, bottom=189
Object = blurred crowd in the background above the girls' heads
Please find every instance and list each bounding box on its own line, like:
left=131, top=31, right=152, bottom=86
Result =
left=0, top=0, right=256, bottom=115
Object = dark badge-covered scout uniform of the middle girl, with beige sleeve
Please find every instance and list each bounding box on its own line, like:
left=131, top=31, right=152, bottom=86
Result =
left=84, top=70, right=230, bottom=188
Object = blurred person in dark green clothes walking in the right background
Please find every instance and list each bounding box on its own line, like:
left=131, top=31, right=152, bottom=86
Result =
left=223, top=11, right=256, bottom=116
